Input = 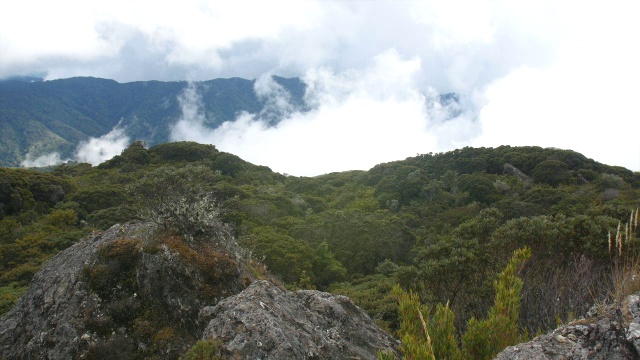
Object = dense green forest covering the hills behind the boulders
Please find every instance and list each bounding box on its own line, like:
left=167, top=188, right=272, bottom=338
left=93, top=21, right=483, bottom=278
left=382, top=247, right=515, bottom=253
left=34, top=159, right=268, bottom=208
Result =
left=0, top=142, right=640, bottom=346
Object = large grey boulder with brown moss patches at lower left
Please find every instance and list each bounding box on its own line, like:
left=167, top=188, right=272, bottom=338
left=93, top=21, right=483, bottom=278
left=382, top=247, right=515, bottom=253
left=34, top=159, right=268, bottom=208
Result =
left=0, top=224, right=251, bottom=359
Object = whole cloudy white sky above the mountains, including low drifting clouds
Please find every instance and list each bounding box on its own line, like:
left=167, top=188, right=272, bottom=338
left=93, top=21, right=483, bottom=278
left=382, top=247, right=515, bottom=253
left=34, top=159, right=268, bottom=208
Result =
left=0, top=0, right=640, bottom=175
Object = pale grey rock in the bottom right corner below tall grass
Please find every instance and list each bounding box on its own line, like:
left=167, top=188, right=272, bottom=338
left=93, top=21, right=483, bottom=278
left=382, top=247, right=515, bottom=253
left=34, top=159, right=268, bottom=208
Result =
left=496, top=293, right=640, bottom=360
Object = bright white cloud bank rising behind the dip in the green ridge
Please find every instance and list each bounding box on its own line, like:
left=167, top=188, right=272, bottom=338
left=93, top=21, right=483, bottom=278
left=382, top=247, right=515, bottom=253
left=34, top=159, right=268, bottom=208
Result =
left=172, top=51, right=469, bottom=175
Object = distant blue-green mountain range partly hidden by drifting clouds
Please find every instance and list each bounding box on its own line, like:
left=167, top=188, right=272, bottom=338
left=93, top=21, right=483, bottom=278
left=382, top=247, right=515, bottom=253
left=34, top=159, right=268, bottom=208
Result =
left=0, top=76, right=306, bottom=166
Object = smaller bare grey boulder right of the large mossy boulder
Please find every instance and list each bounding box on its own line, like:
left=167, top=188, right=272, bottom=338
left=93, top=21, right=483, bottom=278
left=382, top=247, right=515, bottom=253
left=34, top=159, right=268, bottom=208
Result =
left=202, top=281, right=399, bottom=359
